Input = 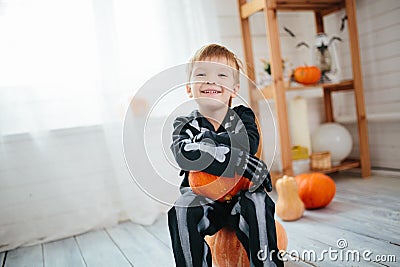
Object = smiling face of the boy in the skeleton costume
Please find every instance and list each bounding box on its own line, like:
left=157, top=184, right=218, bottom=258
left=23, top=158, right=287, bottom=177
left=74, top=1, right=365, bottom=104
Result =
left=186, top=58, right=239, bottom=108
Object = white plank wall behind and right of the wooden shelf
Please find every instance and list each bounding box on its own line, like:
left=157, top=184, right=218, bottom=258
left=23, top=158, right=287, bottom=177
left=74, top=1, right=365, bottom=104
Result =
left=217, top=0, right=400, bottom=169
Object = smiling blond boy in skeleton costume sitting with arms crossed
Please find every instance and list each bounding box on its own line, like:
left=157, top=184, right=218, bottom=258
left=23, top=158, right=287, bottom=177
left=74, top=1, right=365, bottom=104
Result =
left=168, top=44, right=283, bottom=266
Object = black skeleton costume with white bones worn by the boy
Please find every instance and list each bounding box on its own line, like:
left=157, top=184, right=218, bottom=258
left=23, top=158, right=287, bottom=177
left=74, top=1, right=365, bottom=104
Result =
left=168, top=106, right=283, bottom=267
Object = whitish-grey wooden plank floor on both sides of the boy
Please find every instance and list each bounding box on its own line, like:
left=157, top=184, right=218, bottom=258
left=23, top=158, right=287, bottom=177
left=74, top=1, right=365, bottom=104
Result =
left=0, top=173, right=400, bottom=267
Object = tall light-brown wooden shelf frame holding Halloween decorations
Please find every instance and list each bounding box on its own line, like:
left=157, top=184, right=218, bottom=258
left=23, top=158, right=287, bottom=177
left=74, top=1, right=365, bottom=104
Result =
left=238, top=0, right=371, bottom=180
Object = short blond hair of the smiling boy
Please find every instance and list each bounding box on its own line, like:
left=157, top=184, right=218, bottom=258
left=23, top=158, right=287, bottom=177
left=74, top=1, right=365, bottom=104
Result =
left=188, top=44, right=243, bottom=83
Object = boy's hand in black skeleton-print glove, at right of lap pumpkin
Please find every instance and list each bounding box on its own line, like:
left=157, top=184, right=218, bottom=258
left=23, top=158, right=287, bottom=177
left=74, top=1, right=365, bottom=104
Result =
left=237, top=151, right=272, bottom=192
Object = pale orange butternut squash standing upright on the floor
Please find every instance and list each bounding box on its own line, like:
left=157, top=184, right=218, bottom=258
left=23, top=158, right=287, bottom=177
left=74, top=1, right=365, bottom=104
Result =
left=275, top=175, right=304, bottom=221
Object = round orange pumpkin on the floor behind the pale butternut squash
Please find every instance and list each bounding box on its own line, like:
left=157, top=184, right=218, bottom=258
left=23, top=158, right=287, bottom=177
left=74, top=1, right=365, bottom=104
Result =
left=296, top=172, right=336, bottom=209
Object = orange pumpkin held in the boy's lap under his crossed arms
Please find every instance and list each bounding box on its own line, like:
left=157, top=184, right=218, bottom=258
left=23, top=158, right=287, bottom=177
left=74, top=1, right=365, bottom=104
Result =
left=189, top=171, right=250, bottom=201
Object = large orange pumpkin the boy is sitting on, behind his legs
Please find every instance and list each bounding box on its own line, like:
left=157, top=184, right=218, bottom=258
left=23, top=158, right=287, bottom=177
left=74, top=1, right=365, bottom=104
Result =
left=206, top=221, right=288, bottom=267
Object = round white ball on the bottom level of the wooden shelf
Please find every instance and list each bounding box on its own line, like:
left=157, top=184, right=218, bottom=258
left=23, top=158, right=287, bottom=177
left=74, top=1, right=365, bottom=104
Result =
left=311, top=123, right=353, bottom=166
